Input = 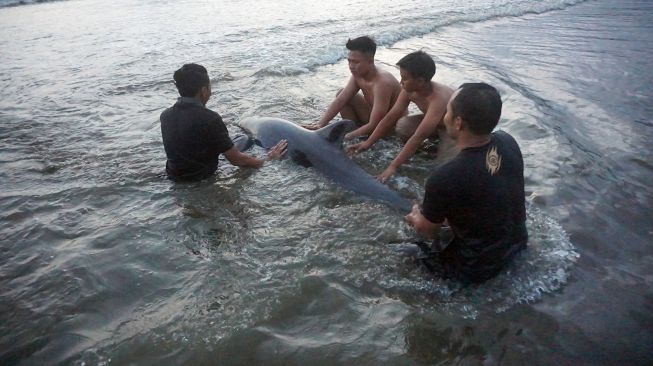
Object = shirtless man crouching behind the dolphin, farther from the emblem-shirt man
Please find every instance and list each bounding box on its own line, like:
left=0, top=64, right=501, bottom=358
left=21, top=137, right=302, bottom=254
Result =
left=307, top=36, right=405, bottom=139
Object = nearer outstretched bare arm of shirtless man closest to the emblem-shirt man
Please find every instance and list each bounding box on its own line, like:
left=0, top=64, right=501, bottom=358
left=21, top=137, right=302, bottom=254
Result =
left=378, top=100, right=446, bottom=182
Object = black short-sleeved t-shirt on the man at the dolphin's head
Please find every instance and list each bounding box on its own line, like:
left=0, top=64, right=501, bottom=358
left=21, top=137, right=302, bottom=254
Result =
left=161, top=97, right=233, bottom=180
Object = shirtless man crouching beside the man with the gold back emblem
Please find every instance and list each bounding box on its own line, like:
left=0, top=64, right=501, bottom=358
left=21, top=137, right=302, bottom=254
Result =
left=348, top=51, right=453, bottom=182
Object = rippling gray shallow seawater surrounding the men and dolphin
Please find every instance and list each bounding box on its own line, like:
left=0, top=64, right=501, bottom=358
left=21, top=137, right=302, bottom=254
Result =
left=0, top=0, right=653, bottom=365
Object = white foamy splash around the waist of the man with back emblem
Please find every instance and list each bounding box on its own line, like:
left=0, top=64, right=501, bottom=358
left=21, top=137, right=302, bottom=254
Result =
left=345, top=203, right=579, bottom=318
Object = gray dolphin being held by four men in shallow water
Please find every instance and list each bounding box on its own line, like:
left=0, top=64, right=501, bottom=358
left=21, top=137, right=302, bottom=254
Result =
left=239, top=117, right=411, bottom=212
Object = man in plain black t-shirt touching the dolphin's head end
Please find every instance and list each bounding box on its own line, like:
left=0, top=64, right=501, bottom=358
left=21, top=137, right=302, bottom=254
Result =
left=161, top=64, right=287, bottom=180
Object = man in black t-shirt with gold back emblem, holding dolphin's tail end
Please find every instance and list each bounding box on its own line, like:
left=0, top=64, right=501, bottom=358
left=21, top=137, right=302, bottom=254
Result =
left=406, top=83, right=528, bottom=283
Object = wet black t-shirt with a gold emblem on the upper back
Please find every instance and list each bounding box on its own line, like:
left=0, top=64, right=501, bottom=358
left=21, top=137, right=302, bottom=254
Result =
left=422, top=131, right=528, bottom=282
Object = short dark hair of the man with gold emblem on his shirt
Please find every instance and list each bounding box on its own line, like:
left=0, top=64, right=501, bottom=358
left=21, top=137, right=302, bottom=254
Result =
left=451, top=83, right=501, bottom=135
